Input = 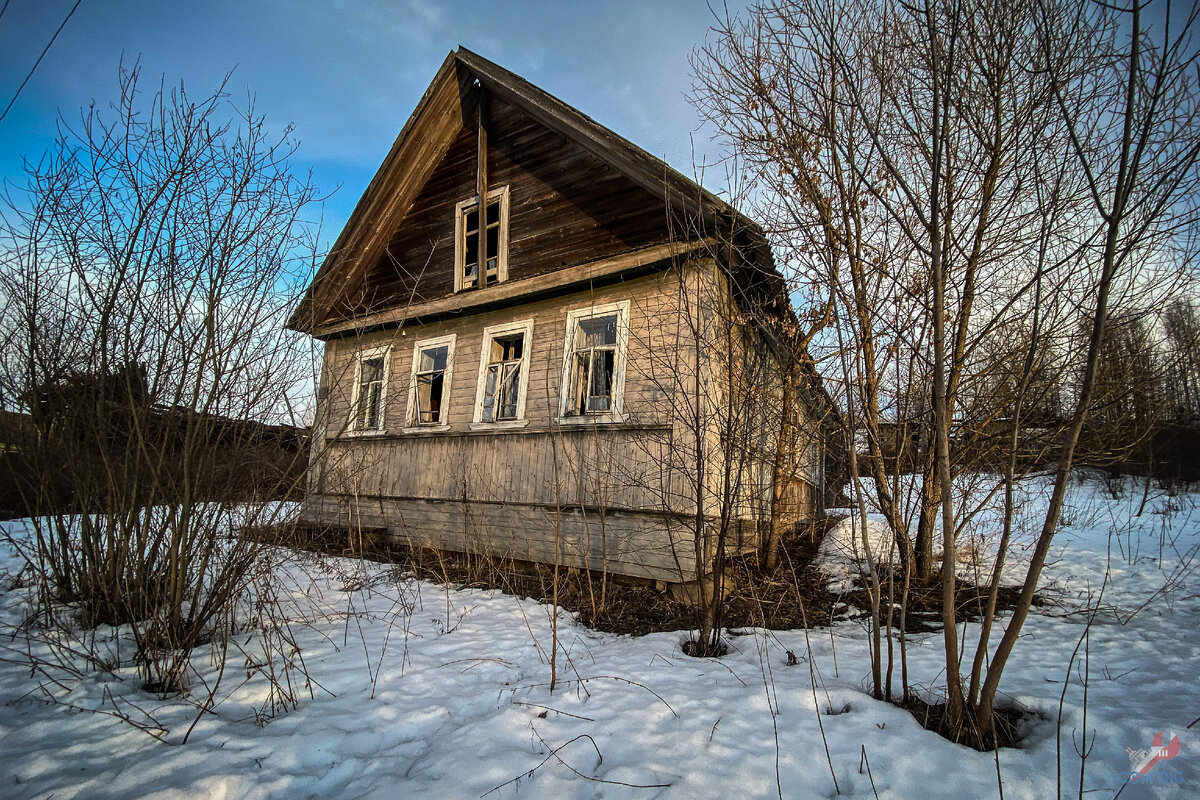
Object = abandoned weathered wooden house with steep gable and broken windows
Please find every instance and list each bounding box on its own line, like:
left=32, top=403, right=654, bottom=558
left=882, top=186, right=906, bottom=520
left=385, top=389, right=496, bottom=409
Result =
left=289, top=49, right=824, bottom=582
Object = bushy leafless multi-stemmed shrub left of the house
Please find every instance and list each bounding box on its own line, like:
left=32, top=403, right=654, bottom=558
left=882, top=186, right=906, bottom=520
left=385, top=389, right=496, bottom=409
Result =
left=0, top=66, right=314, bottom=692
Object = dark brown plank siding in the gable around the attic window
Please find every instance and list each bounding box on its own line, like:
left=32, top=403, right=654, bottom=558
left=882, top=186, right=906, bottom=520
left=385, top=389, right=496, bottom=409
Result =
left=360, top=92, right=670, bottom=311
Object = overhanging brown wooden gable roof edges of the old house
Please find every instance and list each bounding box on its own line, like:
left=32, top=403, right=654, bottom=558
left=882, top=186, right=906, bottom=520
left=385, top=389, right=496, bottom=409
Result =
left=287, top=47, right=781, bottom=332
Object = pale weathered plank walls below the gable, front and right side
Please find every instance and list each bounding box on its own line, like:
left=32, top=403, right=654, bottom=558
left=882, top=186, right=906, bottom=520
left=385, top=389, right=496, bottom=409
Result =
left=305, top=260, right=811, bottom=581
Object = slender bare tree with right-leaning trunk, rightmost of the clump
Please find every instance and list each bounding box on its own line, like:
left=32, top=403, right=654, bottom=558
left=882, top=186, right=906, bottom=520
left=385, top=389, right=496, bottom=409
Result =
left=977, top=2, right=1200, bottom=730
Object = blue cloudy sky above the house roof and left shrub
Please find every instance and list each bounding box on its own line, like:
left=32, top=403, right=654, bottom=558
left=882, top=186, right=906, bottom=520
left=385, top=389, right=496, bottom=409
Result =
left=0, top=0, right=739, bottom=241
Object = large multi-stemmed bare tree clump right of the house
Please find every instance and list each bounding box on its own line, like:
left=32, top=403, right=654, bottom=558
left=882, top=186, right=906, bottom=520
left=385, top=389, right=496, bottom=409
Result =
left=696, top=0, right=1198, bottom=742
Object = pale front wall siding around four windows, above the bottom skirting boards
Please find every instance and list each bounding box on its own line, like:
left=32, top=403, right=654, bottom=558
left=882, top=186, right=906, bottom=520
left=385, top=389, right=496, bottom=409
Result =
left=310, top=272, right=695, bottom=522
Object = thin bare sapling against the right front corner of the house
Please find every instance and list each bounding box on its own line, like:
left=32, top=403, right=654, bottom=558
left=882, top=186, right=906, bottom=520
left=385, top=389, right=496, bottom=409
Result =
left=617, top=200, right=823, bottom=656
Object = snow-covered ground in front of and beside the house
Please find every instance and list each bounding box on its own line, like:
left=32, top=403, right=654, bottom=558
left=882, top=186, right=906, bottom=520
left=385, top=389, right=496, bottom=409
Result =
left=0, top=480, right=1200, bottom=800
